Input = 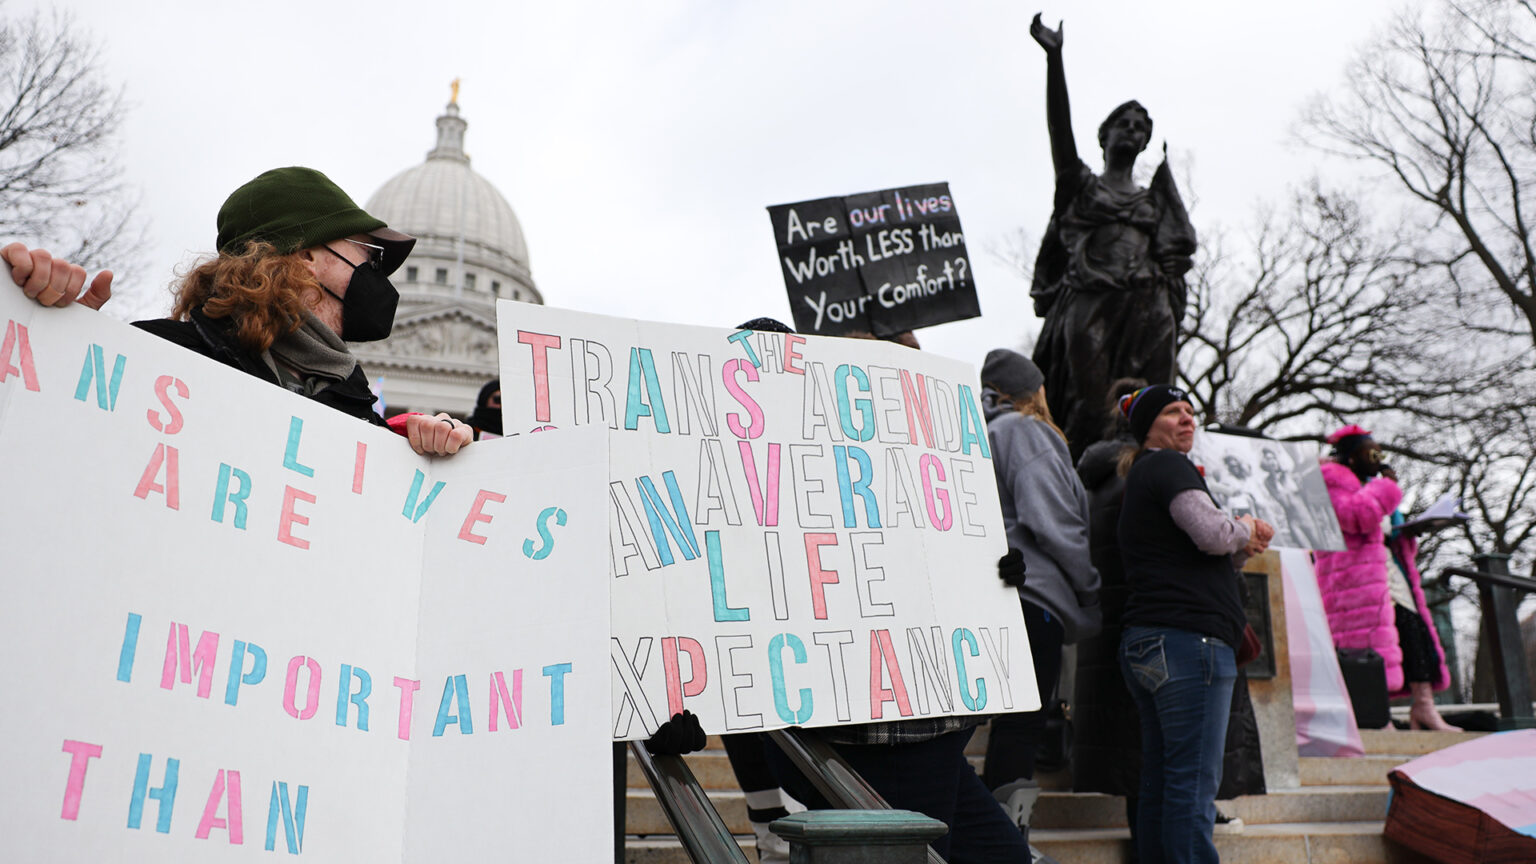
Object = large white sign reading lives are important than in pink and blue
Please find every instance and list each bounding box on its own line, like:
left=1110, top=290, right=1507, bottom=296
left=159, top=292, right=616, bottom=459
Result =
left=0, top=281, right=611, bottom=862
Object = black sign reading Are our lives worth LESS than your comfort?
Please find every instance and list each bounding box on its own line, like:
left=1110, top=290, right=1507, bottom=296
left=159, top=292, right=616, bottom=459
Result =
left=768, top=183, right=982, bottom=337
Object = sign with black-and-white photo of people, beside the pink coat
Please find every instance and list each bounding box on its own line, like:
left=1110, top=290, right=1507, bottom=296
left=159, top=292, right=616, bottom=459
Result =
left=1190, top=430, right=1344, bottom=550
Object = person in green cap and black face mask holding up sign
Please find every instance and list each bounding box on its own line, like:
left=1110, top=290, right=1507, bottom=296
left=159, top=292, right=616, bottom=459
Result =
left=0, top=166, right=472, bottom=455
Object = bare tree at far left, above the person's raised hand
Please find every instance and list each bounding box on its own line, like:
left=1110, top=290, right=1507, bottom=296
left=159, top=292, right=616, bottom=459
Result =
left=0, top=8, right=143, bottom=271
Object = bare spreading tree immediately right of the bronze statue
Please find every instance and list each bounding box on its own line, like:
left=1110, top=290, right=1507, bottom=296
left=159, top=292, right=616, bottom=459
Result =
left=1180, top=186, right=1501, bottom=440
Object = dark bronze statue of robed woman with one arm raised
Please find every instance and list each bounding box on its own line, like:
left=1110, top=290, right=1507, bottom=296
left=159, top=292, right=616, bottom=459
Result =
left=1029, top=15, right=1195, bottom=460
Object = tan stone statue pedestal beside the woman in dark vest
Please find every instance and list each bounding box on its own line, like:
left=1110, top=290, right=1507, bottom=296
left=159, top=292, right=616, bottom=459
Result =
left=1243, top=550, right=1301, bottom=790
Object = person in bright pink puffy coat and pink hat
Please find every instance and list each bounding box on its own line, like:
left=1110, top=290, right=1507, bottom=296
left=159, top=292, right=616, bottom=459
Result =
left=1316, top=426, right=1455, bottom=729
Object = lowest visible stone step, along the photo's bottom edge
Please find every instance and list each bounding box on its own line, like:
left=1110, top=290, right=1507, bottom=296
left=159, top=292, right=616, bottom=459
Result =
left=625, top=821, right=1424, bottom=864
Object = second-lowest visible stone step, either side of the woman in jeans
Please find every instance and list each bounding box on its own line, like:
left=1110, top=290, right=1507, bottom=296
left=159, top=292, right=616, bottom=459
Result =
left=1031, top=786, right=1387, bottom=830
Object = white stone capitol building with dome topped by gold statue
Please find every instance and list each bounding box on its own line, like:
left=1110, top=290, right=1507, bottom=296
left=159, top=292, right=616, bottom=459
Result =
left=352, top=100, right=544, bottom=417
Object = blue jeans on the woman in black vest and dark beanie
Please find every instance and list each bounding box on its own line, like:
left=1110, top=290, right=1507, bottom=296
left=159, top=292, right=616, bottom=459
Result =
left=1120, top=627, right=1238, bottom=864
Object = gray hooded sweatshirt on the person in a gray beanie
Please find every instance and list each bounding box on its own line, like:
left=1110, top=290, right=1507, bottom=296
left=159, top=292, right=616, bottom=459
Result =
left=982, top=387, right=1101, bottom=644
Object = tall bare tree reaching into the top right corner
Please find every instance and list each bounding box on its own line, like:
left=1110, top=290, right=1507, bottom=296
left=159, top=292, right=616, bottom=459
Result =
left=1303, top=2, right=1536, bottom=343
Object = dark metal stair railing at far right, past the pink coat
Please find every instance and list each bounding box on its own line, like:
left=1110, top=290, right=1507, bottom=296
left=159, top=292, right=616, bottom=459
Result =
left=1441, top=553, right=1536, bottom=729
